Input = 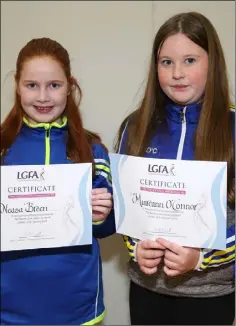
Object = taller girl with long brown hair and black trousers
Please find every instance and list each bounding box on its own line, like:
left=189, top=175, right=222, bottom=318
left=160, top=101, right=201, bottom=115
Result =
left=117, top=12, right=235, bottom=325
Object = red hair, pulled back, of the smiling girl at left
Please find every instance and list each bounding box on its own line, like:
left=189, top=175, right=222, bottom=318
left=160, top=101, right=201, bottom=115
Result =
left=1, top=38, right=104, bottom=171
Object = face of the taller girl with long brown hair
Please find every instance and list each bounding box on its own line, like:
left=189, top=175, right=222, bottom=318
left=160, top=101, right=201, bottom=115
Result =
left=157, top=33, right=208, bottom=105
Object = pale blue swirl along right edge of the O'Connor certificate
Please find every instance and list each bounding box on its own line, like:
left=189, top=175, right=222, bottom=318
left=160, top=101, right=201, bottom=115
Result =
left=202, top=166, right=227, bottom=249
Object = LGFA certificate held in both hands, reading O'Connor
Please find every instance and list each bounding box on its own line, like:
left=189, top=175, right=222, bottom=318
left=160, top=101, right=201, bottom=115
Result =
left=110, top=154, right=227, bottom=249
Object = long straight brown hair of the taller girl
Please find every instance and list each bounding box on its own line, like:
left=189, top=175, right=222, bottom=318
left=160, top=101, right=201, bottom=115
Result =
left=116, top=12, right=235, bottom=206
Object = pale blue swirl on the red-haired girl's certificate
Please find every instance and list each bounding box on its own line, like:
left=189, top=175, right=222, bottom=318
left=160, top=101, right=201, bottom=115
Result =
left=71, top=167, right=92, bottom=246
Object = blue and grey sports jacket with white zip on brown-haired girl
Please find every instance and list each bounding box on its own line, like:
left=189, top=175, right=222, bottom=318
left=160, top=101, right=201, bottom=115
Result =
left=119, top=102, right=235, bottom=297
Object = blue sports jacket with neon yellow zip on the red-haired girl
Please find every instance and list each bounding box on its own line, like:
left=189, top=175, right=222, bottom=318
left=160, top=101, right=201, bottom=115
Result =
left=1, top=117, right=115, bottom=325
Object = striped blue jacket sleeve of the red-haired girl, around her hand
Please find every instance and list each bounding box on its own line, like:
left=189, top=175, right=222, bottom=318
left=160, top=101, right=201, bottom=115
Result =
left=93, top=144, right=116, bottom=239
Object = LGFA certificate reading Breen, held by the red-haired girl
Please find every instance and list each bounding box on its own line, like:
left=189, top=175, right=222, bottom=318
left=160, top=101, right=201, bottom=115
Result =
left=1, top=163, right=92, bottom=251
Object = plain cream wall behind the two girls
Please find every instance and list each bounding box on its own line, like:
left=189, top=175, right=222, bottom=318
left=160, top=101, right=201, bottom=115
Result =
left=1, top=1, right=235, bottom=325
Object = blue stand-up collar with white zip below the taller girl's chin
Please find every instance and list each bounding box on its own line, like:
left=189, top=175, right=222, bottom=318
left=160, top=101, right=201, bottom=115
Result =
left=167, top=101, right=202, bottom=124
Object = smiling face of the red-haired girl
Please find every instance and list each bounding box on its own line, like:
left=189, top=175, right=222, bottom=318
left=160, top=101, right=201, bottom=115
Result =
left=17, top=56, right=69, bottom=124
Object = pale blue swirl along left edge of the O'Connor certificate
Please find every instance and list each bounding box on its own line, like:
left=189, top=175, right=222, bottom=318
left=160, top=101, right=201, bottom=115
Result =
left=109, top=153, right=128, bottom=229
